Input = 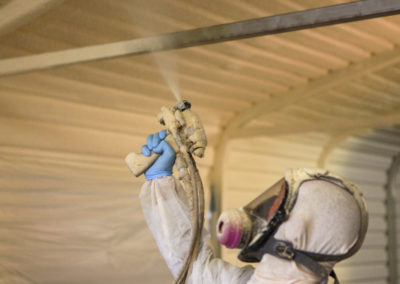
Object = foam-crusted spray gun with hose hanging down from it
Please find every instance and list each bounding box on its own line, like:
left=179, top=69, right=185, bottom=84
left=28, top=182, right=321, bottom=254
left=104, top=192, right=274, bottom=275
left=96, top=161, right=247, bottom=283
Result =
left=125, top=101, right=207, bottom=283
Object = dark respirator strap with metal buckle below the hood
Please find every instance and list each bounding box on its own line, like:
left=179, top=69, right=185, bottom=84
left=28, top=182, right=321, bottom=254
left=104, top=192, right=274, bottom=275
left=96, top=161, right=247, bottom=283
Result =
left=262, top=237, right=339, bottom=284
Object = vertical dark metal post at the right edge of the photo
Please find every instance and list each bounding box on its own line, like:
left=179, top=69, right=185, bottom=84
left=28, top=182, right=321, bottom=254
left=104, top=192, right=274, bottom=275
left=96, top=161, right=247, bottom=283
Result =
left=385, top=153, right=400, bottom=284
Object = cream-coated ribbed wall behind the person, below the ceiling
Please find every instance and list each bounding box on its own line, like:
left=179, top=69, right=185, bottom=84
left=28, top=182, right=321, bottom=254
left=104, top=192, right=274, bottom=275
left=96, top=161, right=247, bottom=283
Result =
left=0, top=113, right=400, bottom=284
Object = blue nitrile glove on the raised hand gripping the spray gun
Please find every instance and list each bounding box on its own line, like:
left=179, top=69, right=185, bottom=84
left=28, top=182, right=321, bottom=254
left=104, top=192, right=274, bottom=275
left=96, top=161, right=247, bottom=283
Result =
left=142, top=130, right=176, bottom=180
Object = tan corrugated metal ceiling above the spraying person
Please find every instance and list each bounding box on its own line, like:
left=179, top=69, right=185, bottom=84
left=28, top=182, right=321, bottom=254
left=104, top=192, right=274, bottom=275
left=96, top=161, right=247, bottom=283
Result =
left=0, top=1, right=400, bottom=139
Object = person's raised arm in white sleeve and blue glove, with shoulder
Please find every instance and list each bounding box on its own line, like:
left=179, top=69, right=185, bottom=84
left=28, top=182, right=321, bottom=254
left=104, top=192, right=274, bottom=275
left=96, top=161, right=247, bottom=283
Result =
left=140, top=133, right=253, bottom=283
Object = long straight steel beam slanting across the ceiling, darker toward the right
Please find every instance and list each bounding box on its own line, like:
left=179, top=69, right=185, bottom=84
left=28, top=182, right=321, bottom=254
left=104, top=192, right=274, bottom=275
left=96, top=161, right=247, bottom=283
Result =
left=0, top=0, right=400, bottom=76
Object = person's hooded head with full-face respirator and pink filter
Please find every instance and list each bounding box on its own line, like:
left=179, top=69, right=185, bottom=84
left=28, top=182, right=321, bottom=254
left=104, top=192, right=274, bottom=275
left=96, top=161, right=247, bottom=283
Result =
left=217, top=169, right=368, bottom=283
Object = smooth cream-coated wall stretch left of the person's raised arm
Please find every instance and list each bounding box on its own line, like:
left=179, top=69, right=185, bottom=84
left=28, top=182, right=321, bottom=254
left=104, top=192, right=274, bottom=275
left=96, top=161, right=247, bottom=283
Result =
left=0, top=147, right=172, bottom=284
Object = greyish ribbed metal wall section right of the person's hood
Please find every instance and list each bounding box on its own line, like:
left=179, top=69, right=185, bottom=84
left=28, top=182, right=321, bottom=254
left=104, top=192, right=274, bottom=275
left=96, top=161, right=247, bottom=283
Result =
left=326, top=127, right=400, bottom=284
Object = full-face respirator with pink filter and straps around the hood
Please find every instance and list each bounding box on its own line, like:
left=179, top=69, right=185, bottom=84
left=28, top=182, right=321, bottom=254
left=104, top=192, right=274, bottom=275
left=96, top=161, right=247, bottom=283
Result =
left=217, top=171, right=368, bottom=284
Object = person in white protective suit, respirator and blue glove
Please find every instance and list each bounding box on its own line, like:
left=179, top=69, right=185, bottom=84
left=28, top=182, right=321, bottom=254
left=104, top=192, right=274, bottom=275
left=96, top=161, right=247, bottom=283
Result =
left=140, top=132, right=368, bottom=284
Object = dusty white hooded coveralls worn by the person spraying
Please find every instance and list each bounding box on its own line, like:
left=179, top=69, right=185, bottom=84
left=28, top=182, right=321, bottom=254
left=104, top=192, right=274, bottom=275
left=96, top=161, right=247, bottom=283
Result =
left=140, top=169, right=361, bottom=284
